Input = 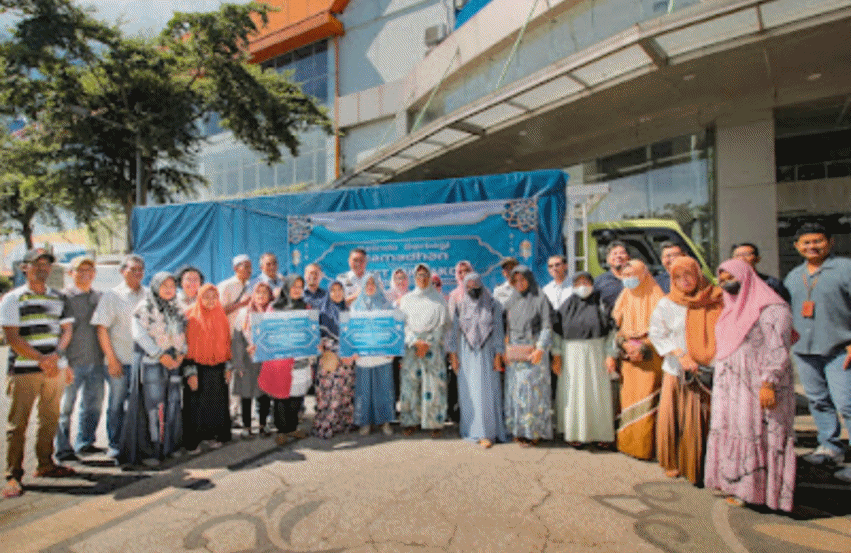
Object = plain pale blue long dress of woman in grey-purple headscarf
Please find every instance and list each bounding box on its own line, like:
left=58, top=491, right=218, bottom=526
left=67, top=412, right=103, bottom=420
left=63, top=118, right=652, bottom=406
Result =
left=449, top=278, right=505, bottom=442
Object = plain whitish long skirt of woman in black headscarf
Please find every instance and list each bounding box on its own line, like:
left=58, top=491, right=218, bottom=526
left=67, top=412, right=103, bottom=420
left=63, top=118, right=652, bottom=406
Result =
left=556, top=338, right=615, bottom=443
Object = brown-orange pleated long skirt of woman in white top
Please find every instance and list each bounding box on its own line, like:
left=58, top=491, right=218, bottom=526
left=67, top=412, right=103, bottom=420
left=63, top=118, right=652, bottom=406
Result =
left=656, top=373, right=712, bottom=485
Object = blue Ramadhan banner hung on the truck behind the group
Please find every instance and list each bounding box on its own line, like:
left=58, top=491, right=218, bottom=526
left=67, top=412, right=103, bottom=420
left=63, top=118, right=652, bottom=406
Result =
left=288, top=197, right=538, bottom=293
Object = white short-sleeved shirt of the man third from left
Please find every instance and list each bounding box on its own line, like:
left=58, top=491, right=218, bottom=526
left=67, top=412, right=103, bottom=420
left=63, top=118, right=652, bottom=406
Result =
left=92, top=282, right=145, bottom=365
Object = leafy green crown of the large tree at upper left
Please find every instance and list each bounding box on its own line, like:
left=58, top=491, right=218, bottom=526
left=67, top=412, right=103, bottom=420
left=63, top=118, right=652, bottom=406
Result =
left=0, top=0, right=332, bottom=247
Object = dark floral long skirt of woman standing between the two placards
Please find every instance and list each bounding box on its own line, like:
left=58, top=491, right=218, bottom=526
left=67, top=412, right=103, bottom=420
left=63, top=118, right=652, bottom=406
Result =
left=312, top=352, right=355, bottom=439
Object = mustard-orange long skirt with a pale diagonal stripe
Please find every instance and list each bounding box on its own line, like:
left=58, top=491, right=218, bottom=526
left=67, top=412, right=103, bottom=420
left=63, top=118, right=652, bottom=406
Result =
left=617, top=351, right=662, bottom=459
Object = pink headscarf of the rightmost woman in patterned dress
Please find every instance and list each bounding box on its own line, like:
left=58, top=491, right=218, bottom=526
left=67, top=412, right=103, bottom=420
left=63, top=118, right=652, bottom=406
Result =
left=715, top=259, right=786, bottom=359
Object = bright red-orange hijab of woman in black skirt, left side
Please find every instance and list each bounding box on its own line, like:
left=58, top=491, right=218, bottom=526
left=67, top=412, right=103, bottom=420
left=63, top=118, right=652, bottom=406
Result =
left=186, top=282, right=231, bottom=366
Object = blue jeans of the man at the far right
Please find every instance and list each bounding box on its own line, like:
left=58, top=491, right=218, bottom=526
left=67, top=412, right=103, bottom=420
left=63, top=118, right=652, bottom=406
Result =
left=795, top=348, right=851, bottom=453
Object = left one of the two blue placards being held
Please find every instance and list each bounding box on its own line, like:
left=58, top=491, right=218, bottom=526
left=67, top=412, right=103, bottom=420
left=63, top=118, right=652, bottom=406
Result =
left=251, top=309, right=319, bottom=363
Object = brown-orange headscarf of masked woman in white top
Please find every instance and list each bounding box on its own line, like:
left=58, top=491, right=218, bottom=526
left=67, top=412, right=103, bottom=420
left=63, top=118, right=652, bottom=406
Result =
left=668, top=255, right=724, bottom=365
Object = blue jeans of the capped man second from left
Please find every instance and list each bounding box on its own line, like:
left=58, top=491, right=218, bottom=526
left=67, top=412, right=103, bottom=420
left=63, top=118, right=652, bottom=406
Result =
left=56, top=365, right=106, bottom=454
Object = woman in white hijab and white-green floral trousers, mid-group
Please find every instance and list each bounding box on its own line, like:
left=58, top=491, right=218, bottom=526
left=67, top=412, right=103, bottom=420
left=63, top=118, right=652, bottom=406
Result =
left=399, top=264, right=449, bottom=438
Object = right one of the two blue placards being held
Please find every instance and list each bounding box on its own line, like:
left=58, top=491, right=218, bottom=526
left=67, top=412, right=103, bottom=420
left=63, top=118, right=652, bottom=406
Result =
left=340, top=309, right=405, bottom=357
